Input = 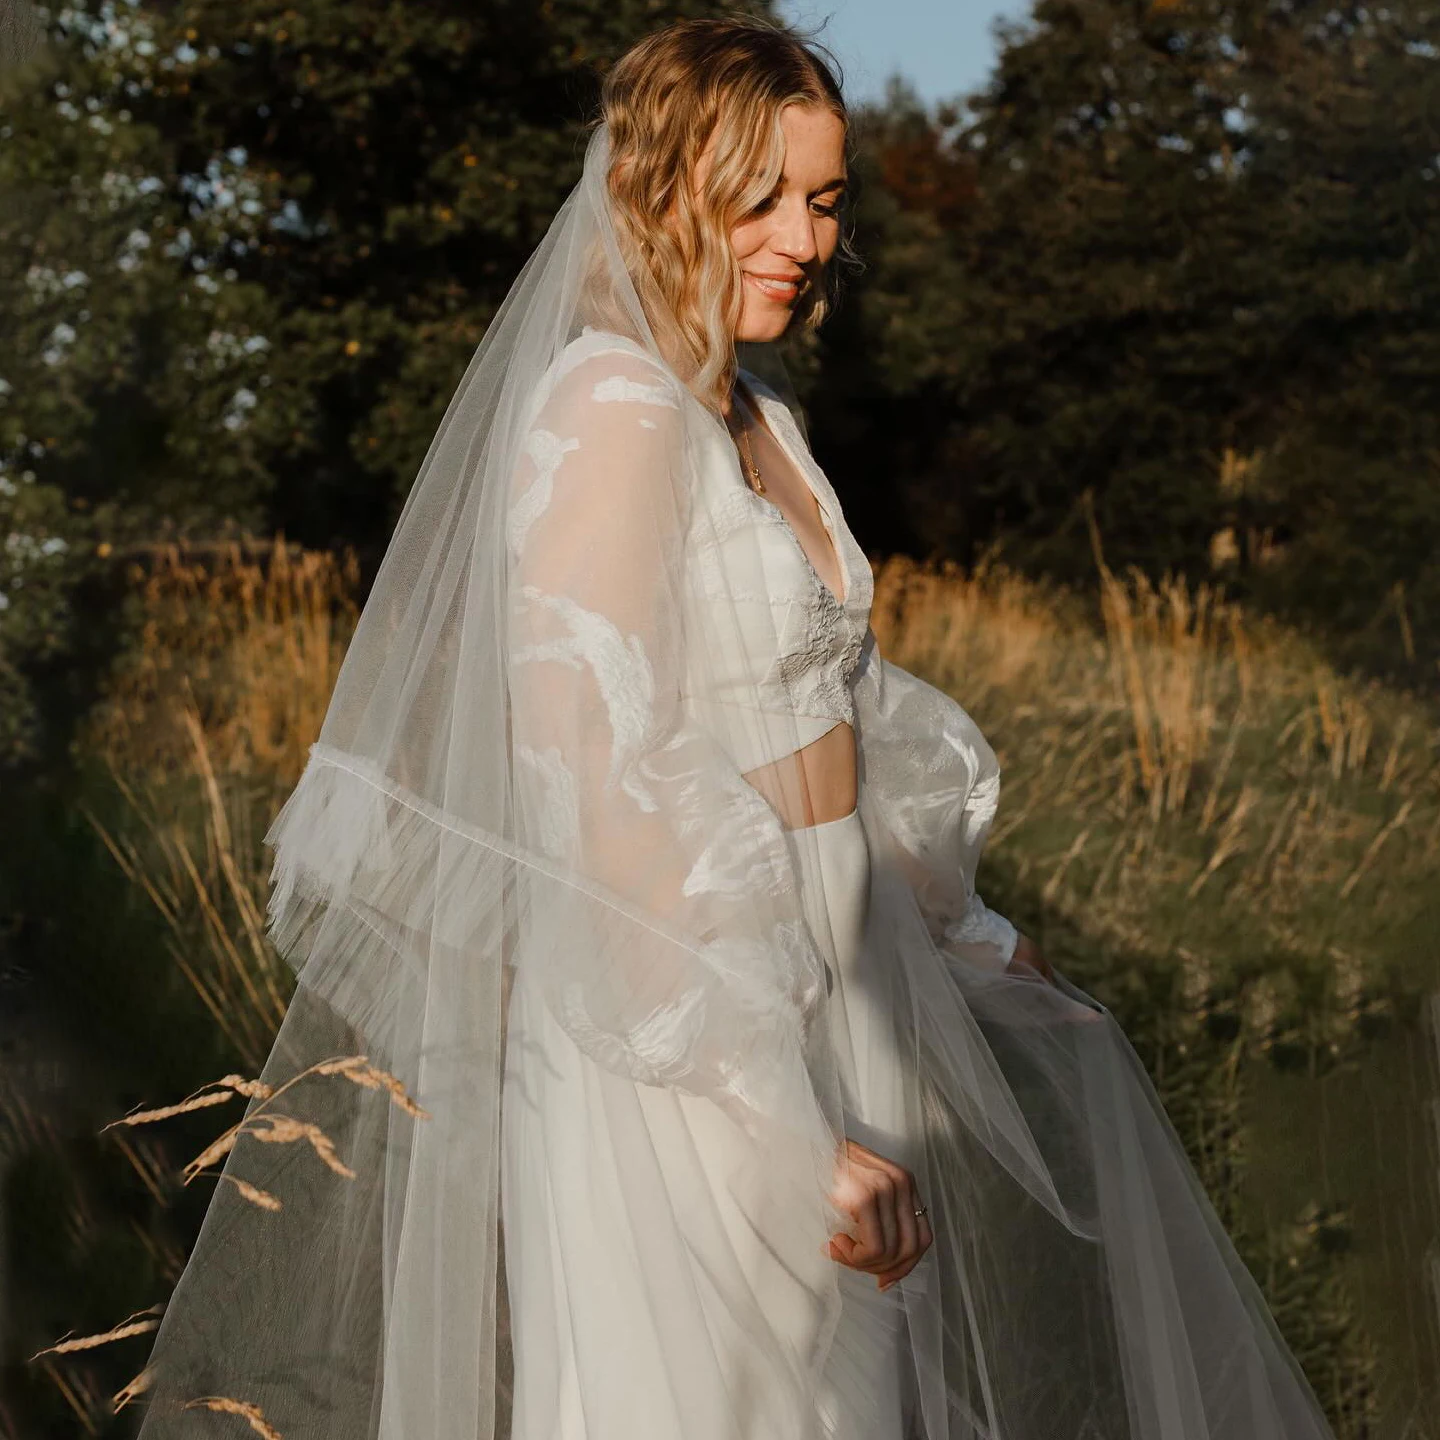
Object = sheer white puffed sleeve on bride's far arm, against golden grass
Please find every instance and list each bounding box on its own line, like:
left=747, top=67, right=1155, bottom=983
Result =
left=855, top=629, right=1018, bottom=969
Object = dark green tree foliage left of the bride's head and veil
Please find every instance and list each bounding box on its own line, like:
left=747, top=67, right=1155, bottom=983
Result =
left=0, top=0, right=765, bottom=755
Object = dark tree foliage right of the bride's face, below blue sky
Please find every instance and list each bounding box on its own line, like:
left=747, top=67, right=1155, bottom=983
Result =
left=816, top=0, right=1440, bottom=681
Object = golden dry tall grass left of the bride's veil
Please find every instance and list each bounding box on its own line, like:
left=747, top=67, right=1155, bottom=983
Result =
left=81, top=540, right=356, bottom=1068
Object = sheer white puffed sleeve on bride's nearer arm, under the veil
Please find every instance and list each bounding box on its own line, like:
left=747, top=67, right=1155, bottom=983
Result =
left=507, top=342, right=824, bottom=1112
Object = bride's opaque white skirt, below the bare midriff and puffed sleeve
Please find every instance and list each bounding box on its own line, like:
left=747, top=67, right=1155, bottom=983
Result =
left=501, top=809, right=904, bottom=1440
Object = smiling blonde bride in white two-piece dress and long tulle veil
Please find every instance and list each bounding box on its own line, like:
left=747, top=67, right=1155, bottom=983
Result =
left=123, top=19, right=1329, bottom=1440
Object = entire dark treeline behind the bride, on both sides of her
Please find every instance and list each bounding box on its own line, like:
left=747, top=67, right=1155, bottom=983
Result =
left=8, top=0, right=1440, bottom=753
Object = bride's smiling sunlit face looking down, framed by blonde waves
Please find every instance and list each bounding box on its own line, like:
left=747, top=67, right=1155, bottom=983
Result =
left=696, top=105, right=847, bottom=340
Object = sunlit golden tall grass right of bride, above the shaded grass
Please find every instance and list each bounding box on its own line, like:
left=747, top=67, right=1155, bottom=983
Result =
left=874, top=559, right=1440, bottom=1002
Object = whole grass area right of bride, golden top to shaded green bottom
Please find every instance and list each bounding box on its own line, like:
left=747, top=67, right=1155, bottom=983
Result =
left=874, top=547, right=1440, bottom=1437
